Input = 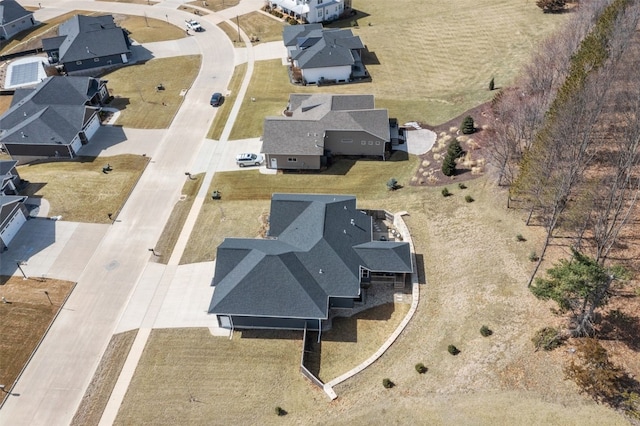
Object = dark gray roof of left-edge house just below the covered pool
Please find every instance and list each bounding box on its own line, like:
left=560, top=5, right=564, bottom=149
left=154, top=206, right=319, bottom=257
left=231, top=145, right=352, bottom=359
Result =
left=0, top=77, right=101, bottom=144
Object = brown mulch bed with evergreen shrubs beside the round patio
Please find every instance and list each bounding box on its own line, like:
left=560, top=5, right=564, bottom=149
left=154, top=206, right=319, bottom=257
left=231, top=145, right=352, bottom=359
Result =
left=409, top=102, right=493, bottom=186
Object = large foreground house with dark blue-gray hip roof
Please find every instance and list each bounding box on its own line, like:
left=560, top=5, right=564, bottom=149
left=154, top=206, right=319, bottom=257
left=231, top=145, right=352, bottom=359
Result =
left=209, top=194, right=413, bottom=332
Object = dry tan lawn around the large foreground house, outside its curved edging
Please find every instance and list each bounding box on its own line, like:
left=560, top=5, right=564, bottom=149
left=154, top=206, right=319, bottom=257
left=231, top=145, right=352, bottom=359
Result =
left=112, top=175, right=625, bottom=425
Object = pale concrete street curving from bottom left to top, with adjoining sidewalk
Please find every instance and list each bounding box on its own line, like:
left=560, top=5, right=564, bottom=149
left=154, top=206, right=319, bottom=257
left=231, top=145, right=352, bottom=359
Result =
left=0, top=0, right=262, bottom=425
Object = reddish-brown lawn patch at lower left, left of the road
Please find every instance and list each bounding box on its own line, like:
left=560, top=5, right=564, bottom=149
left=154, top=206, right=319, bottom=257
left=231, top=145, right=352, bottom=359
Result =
left=0, top=276, right=74, bottom=400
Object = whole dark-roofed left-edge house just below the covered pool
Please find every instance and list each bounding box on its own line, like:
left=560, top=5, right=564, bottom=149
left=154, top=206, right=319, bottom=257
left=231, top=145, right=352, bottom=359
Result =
left=0, top=77, right=109, bottom=163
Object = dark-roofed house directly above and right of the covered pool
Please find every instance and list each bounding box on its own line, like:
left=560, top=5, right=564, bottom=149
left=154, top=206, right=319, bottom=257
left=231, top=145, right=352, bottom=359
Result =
left=42, top=15, right=131, bottom=74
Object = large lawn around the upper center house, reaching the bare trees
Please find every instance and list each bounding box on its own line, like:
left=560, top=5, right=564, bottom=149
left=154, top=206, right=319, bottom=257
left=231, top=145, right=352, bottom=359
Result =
left=231, top=0, right=567, bottom=139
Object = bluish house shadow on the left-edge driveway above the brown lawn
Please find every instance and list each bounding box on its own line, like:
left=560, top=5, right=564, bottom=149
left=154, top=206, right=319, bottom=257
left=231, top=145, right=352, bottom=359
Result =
left=0, top=218, right=57, bottom=285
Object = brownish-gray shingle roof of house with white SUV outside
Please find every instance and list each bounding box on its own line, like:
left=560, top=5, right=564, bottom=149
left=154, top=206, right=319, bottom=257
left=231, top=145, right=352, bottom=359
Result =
left=262, top=94, right=390, bottom=155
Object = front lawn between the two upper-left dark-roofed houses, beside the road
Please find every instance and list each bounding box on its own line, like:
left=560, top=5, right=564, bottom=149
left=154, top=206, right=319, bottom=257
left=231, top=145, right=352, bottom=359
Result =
left=103, top=55, right=201, bottom=129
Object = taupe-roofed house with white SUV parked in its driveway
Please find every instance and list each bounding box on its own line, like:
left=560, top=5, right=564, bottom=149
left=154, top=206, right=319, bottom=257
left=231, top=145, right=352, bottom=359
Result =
left=261, top=94, right=398, bottom=170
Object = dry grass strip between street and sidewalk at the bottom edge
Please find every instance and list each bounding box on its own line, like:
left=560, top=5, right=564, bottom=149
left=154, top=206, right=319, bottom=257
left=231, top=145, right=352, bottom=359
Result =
left=71, top=330, right=138, bottom=426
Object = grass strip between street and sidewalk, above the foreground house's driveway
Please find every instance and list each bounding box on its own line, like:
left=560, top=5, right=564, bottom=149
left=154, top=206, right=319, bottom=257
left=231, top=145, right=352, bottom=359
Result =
left=154, top=173, right=204, bottom=264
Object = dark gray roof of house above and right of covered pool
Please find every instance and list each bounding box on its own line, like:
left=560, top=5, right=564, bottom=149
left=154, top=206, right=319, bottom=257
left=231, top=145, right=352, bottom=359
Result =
left=42, top=15, right=130, bottom=63
